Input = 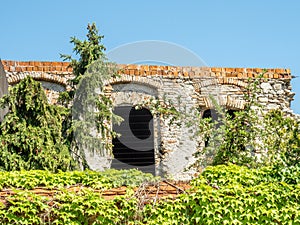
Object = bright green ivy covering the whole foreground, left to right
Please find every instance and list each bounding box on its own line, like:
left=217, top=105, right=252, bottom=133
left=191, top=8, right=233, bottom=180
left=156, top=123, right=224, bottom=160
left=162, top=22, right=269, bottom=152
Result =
left=0, top=164, right=300, bottom=224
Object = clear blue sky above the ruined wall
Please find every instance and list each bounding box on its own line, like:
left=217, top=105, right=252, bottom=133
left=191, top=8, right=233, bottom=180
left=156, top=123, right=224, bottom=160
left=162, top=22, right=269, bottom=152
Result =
left=0, top=0, right=300, bottom=113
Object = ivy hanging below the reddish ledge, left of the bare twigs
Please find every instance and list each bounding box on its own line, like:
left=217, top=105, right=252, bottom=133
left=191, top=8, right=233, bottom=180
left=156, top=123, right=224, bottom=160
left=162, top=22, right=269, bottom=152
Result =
left=0, top=189, right=136, bottom=225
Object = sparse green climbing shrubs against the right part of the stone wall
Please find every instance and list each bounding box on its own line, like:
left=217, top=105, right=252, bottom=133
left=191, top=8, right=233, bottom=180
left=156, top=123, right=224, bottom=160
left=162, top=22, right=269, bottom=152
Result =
left=195, top=76, right=300, bottom=168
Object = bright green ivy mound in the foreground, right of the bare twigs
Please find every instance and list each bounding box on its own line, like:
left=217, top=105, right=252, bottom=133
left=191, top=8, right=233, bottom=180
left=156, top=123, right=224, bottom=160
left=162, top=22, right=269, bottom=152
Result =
left=144, top=165, right=300, bottom=224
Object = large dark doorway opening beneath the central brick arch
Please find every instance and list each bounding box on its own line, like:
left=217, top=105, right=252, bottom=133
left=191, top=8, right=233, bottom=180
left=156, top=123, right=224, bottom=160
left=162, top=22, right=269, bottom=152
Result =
left=111, top=106, right=155, bottom=174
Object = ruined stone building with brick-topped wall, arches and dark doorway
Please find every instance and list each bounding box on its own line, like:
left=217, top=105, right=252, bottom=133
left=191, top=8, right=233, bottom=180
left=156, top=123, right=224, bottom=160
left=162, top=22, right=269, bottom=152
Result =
left=1, top=60, right=294, bottom=179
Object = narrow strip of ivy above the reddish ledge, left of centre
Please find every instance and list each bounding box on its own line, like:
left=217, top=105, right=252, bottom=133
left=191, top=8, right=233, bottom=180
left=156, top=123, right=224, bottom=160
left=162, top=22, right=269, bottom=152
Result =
left=0, top=169, right=157, bottom=189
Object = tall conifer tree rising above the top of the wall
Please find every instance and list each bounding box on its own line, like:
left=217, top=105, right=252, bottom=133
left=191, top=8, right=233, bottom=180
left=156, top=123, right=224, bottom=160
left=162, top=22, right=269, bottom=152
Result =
left=59, top=23, right=121, bottom=167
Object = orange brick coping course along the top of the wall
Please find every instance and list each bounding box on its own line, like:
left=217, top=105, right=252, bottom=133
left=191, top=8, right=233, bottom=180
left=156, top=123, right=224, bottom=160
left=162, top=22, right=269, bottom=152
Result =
left=1, top=60, right=292, bottom=79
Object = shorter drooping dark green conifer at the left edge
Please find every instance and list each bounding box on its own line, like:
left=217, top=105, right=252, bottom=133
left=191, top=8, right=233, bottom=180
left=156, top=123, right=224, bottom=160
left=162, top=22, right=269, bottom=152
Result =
left=0, top=77, right=72, bottom=171
